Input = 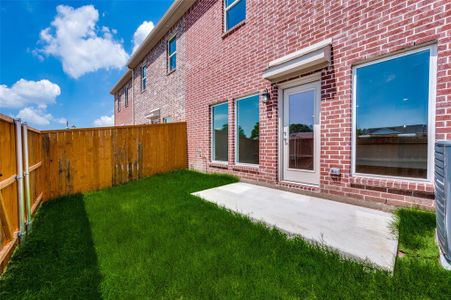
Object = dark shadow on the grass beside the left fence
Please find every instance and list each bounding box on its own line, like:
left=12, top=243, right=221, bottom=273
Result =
left=0, top=194, right=101, bottom=299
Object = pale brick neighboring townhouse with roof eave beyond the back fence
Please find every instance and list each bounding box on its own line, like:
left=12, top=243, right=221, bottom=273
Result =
left=111, top=0, right=194, bottom=125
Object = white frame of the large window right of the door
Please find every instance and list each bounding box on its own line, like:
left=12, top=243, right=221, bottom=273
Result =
left=351, top=44, right=437, bottom=182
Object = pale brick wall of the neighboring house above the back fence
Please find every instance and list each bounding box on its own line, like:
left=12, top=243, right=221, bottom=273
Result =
left=133, top=18, right=186, bottom=124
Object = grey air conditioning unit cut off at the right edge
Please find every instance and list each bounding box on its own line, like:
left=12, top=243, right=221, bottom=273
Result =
left=435, top=141, right=451, bottom=270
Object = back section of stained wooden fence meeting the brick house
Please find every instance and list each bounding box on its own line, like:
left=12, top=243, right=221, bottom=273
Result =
left=42, top=123, right=188, bottom=199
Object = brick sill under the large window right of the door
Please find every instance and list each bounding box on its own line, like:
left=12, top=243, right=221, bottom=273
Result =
left=350, top=175, right=434, bottom=199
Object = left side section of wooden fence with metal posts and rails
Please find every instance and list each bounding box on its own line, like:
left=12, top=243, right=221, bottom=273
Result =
left=0, top=114, right=44, bottom=271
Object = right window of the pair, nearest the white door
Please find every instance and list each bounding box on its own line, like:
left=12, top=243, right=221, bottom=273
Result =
left=235, top=95, right=260, bottom=164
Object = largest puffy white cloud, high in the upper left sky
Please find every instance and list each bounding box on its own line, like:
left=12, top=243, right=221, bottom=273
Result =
left=34, top=5, right=128, bottom=78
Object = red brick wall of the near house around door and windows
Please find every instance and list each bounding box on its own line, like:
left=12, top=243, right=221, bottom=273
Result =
left=185, top=0, right=451, bottom=207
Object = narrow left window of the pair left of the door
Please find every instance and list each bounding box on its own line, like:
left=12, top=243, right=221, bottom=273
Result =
left=211, top=103, right=229, bottom=162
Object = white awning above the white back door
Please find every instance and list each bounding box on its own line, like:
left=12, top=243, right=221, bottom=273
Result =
left=263, top=38, right=332, bottom=81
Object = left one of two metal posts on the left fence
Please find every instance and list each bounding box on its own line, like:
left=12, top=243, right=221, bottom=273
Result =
left=14, top=119, right=25, bottom=239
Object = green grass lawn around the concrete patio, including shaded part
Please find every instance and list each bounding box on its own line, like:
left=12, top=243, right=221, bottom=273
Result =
left=0, top=171, right=451, bottom=299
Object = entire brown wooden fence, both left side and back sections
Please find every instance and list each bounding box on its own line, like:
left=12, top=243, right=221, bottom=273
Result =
left=0, top=114, right=188, bottom=273
